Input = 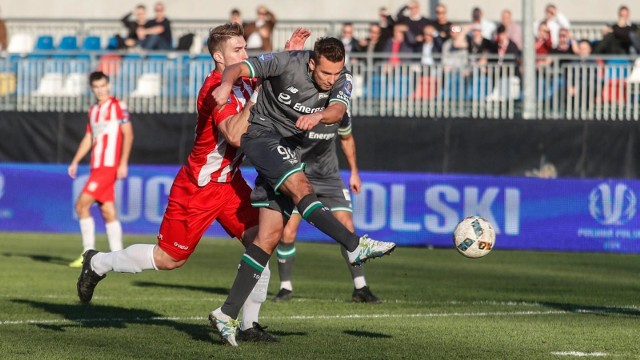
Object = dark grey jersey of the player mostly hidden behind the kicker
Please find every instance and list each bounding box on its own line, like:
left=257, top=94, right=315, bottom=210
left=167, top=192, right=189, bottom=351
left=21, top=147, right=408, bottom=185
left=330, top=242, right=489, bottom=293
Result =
left=300, top=111, right=351, bottom=183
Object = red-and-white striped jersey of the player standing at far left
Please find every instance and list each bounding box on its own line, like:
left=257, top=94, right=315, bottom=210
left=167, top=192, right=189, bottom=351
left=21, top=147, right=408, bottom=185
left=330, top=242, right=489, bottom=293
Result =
left=87, top=97, right=129, bottom=169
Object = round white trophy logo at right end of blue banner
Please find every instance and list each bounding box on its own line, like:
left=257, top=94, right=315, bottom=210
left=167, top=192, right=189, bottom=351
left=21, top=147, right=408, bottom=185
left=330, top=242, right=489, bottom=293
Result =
left=589, top=183, right=637, bottom=225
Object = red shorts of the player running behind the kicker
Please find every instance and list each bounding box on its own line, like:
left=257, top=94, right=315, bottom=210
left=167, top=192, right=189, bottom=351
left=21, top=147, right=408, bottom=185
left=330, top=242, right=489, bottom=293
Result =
left=158, top=167, right=258, bottom=260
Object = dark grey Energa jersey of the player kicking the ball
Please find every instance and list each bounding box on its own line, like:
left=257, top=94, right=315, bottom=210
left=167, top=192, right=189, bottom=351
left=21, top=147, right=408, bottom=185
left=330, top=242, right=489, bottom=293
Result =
left=244, top=51, right=353, bottom=144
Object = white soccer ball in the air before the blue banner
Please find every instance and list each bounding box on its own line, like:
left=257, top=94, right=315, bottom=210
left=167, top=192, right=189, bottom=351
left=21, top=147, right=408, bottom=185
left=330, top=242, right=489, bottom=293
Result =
left=453, top=216, right=496, bottom=259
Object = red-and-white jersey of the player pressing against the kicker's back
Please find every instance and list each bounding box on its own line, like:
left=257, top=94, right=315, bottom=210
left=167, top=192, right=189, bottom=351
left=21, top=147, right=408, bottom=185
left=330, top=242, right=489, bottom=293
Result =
left=186, top=70, right=256, bottom=186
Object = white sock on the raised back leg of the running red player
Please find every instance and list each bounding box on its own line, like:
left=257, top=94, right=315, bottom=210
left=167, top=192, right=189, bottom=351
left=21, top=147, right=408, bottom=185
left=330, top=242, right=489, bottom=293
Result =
left=91, top=244, right=157, bottom=276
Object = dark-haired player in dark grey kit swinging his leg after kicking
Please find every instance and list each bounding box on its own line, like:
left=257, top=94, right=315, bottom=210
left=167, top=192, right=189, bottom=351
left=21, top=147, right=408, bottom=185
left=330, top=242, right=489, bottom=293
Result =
left=210, top=38, right=396, bottom=344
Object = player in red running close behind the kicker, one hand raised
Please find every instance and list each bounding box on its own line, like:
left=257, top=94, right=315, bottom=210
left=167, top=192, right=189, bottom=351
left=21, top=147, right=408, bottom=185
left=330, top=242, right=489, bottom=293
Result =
left=77, top=24, right=310, bottom=342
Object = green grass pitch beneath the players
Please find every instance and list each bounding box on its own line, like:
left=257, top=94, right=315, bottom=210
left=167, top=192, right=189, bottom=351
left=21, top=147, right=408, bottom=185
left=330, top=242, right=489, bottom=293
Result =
left=0, top=233, right=640, bottom=359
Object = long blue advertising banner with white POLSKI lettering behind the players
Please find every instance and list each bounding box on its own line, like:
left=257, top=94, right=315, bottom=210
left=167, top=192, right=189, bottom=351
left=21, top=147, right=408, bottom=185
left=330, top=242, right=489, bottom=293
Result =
left=0, top=163, right=640, bottom=253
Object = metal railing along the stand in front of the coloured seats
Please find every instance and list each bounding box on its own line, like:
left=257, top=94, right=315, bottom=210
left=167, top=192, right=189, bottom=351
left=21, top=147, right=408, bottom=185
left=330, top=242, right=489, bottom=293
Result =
left=0, top=52, right=640, bottom=121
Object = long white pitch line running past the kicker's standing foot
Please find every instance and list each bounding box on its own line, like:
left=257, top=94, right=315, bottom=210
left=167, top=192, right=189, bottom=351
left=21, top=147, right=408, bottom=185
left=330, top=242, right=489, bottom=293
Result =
left=0, top=311, right=568, bottom=325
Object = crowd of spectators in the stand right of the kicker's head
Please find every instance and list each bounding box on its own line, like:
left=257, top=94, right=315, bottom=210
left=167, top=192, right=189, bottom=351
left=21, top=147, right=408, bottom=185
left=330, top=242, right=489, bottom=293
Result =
left=342, top=0, right=640, bottom=67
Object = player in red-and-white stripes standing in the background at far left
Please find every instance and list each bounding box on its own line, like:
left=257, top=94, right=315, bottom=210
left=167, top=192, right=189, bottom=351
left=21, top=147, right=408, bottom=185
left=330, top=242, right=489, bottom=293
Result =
left=68, top=71, right=133, bottom=268
